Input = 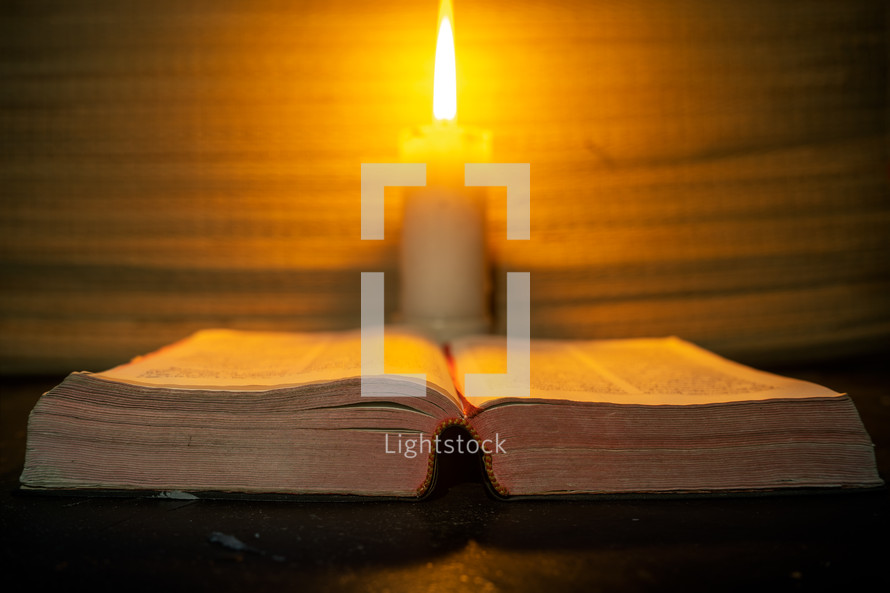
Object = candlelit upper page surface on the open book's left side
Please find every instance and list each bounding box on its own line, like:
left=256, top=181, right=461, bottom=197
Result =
left=95, top=328, right=458, bottom=403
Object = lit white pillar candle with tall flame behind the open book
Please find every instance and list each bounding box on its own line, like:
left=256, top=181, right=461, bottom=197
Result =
left=399, top=0, right=491, bottom=341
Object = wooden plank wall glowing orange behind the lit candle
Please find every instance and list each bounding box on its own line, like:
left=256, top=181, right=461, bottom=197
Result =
left=0, top=0, right=890, bottom=373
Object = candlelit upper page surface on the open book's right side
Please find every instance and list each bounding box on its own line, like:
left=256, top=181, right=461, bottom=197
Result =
left=451, top=336, right=840, bottom=407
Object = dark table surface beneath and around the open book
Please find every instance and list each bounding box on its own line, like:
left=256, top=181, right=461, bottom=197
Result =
left=0, top=354, right=890, bottom=592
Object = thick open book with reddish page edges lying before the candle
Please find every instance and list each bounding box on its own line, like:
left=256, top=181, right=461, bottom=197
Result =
left=21, top=328, right=882, bottom=498
